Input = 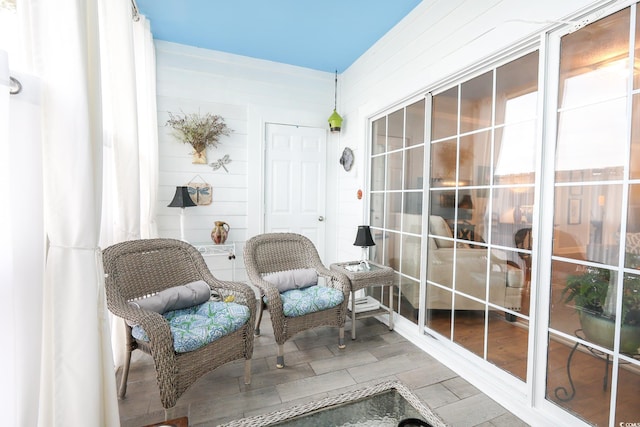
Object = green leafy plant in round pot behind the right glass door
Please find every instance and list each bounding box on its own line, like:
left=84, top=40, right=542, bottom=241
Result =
left=562, top=267, right=640, bottom=354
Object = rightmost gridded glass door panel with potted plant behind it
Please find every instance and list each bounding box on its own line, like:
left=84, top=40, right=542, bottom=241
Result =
left=541, top=6, right=640, bottom=426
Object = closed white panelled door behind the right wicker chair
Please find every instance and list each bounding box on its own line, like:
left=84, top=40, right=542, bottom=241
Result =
left=264, top=124, right=327, bottom=257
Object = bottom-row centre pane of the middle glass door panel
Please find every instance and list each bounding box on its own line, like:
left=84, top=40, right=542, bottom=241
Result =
left=453, top=295, right=485, bottom=358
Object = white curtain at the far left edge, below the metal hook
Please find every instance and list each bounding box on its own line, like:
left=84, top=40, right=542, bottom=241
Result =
left=0, top=51, right=44, bottom=426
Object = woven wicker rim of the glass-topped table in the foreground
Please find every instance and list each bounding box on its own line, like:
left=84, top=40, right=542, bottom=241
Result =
left=220, top=381, right=447, bottom=427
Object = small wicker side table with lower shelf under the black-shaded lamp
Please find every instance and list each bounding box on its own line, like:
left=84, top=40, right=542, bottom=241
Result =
left=331, top=261, right=394, bottom=340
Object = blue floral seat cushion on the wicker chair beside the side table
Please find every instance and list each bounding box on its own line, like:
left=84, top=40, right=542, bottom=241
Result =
left=266, top=285, right=344, bottom=317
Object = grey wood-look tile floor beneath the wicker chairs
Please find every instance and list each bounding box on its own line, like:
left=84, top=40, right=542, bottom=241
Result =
left=119, top=312, right=526, bottom=427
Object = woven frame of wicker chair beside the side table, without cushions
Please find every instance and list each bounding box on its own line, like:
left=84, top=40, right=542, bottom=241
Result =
left=244, top=233, right=350, bottom=368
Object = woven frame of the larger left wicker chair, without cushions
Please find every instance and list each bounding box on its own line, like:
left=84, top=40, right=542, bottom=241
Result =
left=103, top=239, right=256, bottom=409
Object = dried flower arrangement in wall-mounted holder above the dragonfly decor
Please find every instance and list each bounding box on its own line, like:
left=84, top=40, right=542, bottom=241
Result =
left=165, top=112, right=231, bottom=164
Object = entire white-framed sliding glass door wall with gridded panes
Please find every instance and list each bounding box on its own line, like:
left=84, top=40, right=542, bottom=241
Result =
left=370, top=1, right=640, bottom=426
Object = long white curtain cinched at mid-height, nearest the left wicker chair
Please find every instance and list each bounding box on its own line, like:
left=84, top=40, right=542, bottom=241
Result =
left=27, top=0, right=120, bottom=426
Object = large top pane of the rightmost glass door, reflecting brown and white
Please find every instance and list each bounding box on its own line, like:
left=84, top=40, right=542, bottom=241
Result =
left=558, top=9, right=629, bottom=108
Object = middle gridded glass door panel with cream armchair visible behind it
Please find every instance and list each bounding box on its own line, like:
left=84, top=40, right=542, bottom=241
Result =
left=425, top=51, right=538, bottom=381
